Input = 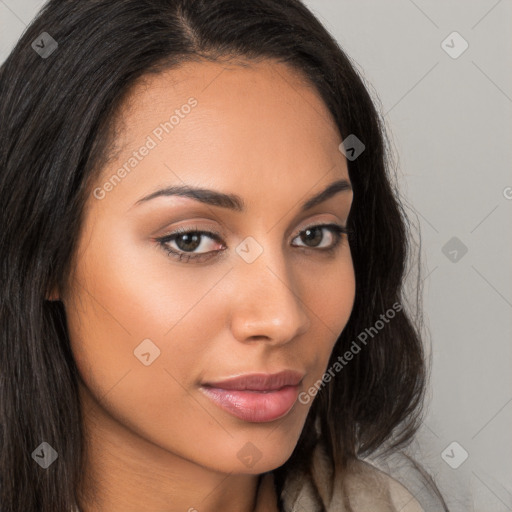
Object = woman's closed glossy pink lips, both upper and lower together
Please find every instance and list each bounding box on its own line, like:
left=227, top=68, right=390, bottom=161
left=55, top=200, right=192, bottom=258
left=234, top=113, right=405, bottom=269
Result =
left=200, top=370, right=304, bottom=423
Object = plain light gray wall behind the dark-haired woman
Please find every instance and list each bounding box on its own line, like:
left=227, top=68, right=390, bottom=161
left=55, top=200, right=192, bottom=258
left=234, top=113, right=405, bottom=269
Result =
left=0, top=0, right=512, bottom=512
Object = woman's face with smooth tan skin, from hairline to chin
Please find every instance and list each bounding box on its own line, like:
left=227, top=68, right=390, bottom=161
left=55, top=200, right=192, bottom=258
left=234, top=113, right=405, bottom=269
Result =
left=61, top=61, right=355, bottom=474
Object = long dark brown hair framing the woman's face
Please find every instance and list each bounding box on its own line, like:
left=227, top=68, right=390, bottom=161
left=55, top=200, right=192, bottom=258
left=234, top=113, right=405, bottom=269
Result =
left=0, top=0, right=444, bottom=512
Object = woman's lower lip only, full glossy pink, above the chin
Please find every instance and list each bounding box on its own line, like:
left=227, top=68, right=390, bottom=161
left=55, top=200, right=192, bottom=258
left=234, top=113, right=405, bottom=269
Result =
left=200, top=385, right=299, bottom=423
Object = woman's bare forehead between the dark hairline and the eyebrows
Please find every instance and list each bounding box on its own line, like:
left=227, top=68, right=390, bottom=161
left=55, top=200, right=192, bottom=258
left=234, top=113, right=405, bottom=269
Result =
left=93, top=60, right=348, bottom=211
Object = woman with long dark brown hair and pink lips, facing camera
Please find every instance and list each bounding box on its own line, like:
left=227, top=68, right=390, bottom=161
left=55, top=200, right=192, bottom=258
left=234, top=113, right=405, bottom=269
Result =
left=0, top=0, right=446, bottom=512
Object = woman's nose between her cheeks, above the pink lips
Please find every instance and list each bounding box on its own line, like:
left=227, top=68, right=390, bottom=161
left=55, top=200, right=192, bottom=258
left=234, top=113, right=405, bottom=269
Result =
left=231, top=251, right=310, bottom=345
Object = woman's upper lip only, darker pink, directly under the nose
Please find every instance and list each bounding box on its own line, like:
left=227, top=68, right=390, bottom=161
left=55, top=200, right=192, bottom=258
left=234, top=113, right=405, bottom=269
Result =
left=203, top=370, right=304, bottom=391
